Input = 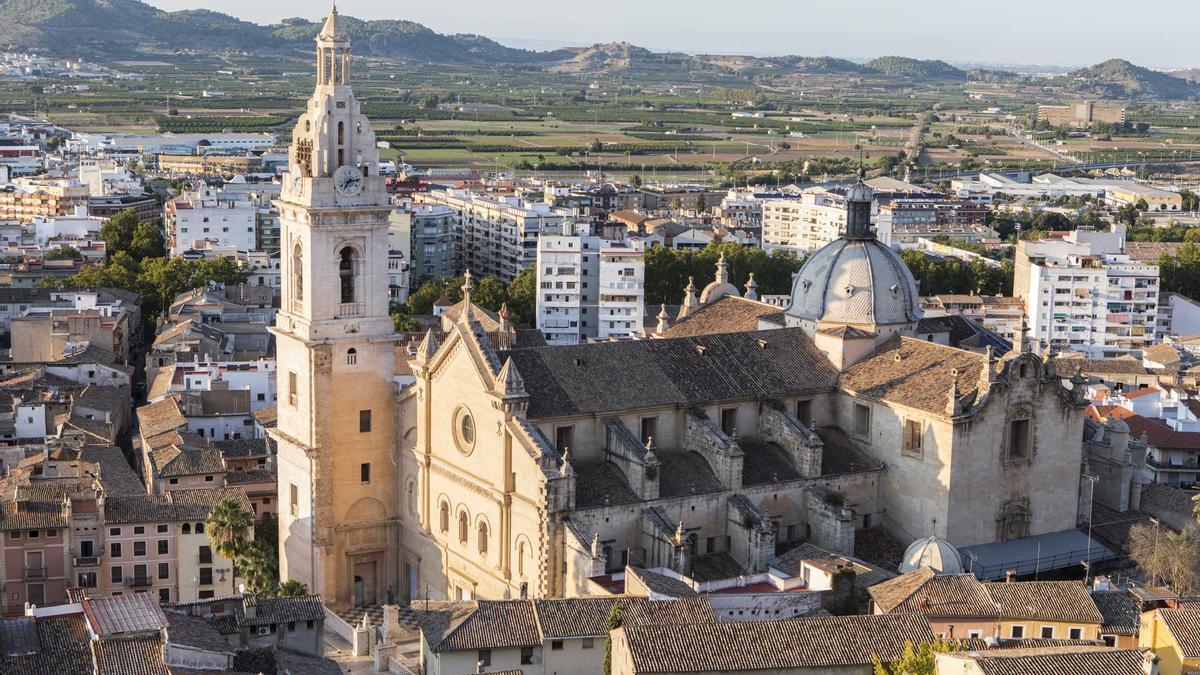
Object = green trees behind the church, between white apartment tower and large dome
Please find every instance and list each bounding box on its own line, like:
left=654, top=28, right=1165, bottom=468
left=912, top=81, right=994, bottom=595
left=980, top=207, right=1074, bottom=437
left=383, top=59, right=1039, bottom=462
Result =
left=646, top=241, right=803, bottom=306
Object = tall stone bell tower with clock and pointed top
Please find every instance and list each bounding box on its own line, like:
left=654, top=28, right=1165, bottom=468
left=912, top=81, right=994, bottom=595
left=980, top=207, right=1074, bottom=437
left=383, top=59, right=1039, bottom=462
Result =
left=271, top=7, right=400, bottom=607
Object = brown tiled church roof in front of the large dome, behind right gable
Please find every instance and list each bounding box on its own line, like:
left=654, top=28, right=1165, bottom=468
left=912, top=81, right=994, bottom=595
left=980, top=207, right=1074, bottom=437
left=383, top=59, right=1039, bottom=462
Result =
left=840, top=336, right=984, bottom=416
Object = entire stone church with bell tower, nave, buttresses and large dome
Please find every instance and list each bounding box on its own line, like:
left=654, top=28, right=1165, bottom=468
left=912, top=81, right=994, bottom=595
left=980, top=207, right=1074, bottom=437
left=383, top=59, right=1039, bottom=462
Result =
left=271, top=10, right=1099, bottom=608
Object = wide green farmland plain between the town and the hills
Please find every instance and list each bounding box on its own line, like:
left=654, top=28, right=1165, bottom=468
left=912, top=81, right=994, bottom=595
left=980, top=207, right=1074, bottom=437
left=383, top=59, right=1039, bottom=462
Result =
left=0, top=47, right=1200, bottom=183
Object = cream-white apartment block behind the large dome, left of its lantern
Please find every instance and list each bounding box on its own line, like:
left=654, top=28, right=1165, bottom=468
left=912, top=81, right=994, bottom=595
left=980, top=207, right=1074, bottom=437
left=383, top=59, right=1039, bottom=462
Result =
left=762, top=187, right=878, bottom=253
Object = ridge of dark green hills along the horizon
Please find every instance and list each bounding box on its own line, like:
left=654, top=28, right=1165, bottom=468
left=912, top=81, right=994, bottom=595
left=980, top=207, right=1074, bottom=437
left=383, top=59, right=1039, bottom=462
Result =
left=0, top=0, right=1200, bottom=100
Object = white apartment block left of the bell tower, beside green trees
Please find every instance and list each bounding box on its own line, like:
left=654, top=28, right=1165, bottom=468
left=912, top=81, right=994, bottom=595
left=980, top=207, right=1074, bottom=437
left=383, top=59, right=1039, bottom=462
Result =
left=163, top=187, right=258, bottom=257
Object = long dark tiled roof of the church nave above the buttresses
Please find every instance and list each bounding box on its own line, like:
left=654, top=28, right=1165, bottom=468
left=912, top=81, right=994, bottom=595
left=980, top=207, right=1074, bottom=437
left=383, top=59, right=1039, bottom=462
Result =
left=502, top=328, right=838, bottom=419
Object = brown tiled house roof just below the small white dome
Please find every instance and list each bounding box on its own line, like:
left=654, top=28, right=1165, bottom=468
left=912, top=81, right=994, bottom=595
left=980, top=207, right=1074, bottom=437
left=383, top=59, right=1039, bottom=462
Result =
left=868, top=567, right=998, bottom=617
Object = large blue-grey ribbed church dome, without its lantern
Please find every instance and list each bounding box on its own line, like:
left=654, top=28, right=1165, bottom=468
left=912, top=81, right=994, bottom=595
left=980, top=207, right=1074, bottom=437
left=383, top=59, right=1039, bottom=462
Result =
left=787, top=237, right=920, bottom=325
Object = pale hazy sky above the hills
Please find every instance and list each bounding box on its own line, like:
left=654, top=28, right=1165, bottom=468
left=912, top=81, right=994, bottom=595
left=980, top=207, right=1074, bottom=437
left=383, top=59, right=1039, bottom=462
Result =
left=149, top=0, right=1200, bottom=68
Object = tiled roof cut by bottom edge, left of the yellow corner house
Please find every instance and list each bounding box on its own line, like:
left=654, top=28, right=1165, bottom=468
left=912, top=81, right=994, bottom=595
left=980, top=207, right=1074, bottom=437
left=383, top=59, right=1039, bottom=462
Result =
left=953, top=646, right=1145, bottom=675
